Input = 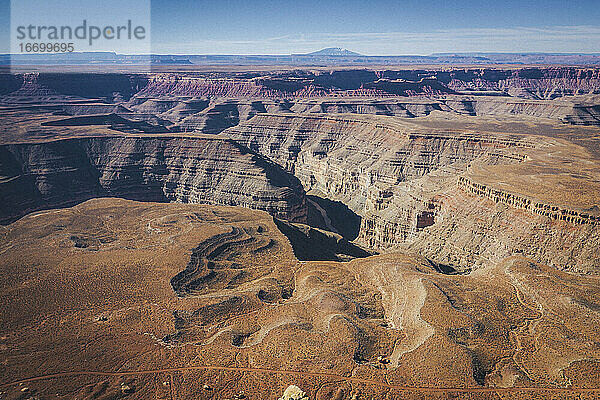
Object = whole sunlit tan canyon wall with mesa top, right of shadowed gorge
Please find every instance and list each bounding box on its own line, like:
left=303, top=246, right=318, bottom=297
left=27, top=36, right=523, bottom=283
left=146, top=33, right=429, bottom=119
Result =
left=225, top=114, right=600, bottom=272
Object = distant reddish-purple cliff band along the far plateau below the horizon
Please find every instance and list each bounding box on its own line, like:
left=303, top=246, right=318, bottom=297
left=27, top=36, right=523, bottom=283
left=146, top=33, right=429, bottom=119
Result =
left=132, top=67, right=600, bottom=99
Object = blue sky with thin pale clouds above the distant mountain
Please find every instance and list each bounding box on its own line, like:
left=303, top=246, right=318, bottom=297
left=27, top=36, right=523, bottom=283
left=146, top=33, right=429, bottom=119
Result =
left=0, top=0, right=600, bottom=55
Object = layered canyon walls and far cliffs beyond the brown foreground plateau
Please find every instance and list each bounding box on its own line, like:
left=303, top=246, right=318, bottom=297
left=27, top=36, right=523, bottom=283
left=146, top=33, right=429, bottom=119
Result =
left=0, top=68, right=600, bottom=272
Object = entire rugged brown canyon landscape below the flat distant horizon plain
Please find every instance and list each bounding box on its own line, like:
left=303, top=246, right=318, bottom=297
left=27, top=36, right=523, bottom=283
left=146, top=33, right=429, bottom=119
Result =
left=0, top=66, right=600, bottom=399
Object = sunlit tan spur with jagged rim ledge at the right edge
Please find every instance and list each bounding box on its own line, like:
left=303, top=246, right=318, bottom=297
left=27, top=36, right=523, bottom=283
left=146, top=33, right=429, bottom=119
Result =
left=410, top=130, right=600, bottom=274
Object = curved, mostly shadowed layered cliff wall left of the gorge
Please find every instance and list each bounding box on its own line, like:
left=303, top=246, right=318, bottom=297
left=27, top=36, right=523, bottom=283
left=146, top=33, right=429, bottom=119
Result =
left=0, top=137, right=306, bottom=222
